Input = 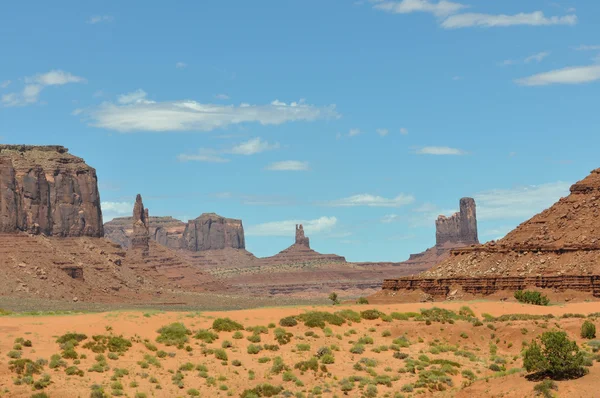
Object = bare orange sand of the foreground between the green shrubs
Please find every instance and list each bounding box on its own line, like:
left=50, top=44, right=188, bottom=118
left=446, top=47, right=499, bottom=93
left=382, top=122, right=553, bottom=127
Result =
left=0, top=301, right=600, bottom=398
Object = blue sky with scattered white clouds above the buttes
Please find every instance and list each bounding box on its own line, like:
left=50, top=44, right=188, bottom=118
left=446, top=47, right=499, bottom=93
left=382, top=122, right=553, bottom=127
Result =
left=0, top=0, right=600, bottom=261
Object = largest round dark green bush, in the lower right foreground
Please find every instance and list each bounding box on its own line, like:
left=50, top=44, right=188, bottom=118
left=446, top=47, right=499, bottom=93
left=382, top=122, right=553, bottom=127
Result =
left=523, top=331, right=586, bottom=379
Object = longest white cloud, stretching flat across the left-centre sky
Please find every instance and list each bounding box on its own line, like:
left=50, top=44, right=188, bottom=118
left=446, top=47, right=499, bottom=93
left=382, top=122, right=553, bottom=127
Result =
left=87, top=95, right=339, bottom=133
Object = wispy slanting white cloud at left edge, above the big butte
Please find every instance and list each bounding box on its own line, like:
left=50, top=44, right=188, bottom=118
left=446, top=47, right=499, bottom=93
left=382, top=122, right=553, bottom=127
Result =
left=2, top=69, right=86, bottom=106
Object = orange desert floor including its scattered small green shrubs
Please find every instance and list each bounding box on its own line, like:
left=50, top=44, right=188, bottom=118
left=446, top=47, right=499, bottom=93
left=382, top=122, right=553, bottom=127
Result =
left=0, top=301, right=600, bottom=398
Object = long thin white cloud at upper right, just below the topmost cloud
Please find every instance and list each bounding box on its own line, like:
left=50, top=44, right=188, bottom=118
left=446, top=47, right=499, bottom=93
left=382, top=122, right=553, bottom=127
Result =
left=442, top=11, right=577, bottom=29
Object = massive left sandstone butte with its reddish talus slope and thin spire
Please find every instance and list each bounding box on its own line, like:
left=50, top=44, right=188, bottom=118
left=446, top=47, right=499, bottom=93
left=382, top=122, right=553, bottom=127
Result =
left=0, top=145, right=222, bottom=302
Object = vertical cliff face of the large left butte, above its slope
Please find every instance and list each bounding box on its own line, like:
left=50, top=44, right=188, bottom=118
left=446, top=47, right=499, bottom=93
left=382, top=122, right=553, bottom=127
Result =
left=0, top=145, right=104, bottom=237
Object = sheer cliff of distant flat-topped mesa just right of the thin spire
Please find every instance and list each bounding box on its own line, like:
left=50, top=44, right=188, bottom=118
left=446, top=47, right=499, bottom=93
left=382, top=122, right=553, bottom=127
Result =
left=181, top=213, right=246, bottom=251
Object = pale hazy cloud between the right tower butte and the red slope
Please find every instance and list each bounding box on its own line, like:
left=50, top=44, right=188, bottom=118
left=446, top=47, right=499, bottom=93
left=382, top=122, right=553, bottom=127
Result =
left=474, top=181, right=570, bottom=220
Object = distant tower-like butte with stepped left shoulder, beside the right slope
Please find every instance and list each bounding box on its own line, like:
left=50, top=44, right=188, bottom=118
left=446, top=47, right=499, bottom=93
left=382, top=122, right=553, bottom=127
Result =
left=435, top=198, right=479, bottom=247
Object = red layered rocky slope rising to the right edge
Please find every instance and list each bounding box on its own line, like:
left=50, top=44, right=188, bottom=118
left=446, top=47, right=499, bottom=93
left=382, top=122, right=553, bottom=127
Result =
left=379, top=169, right=600, bottom=298
